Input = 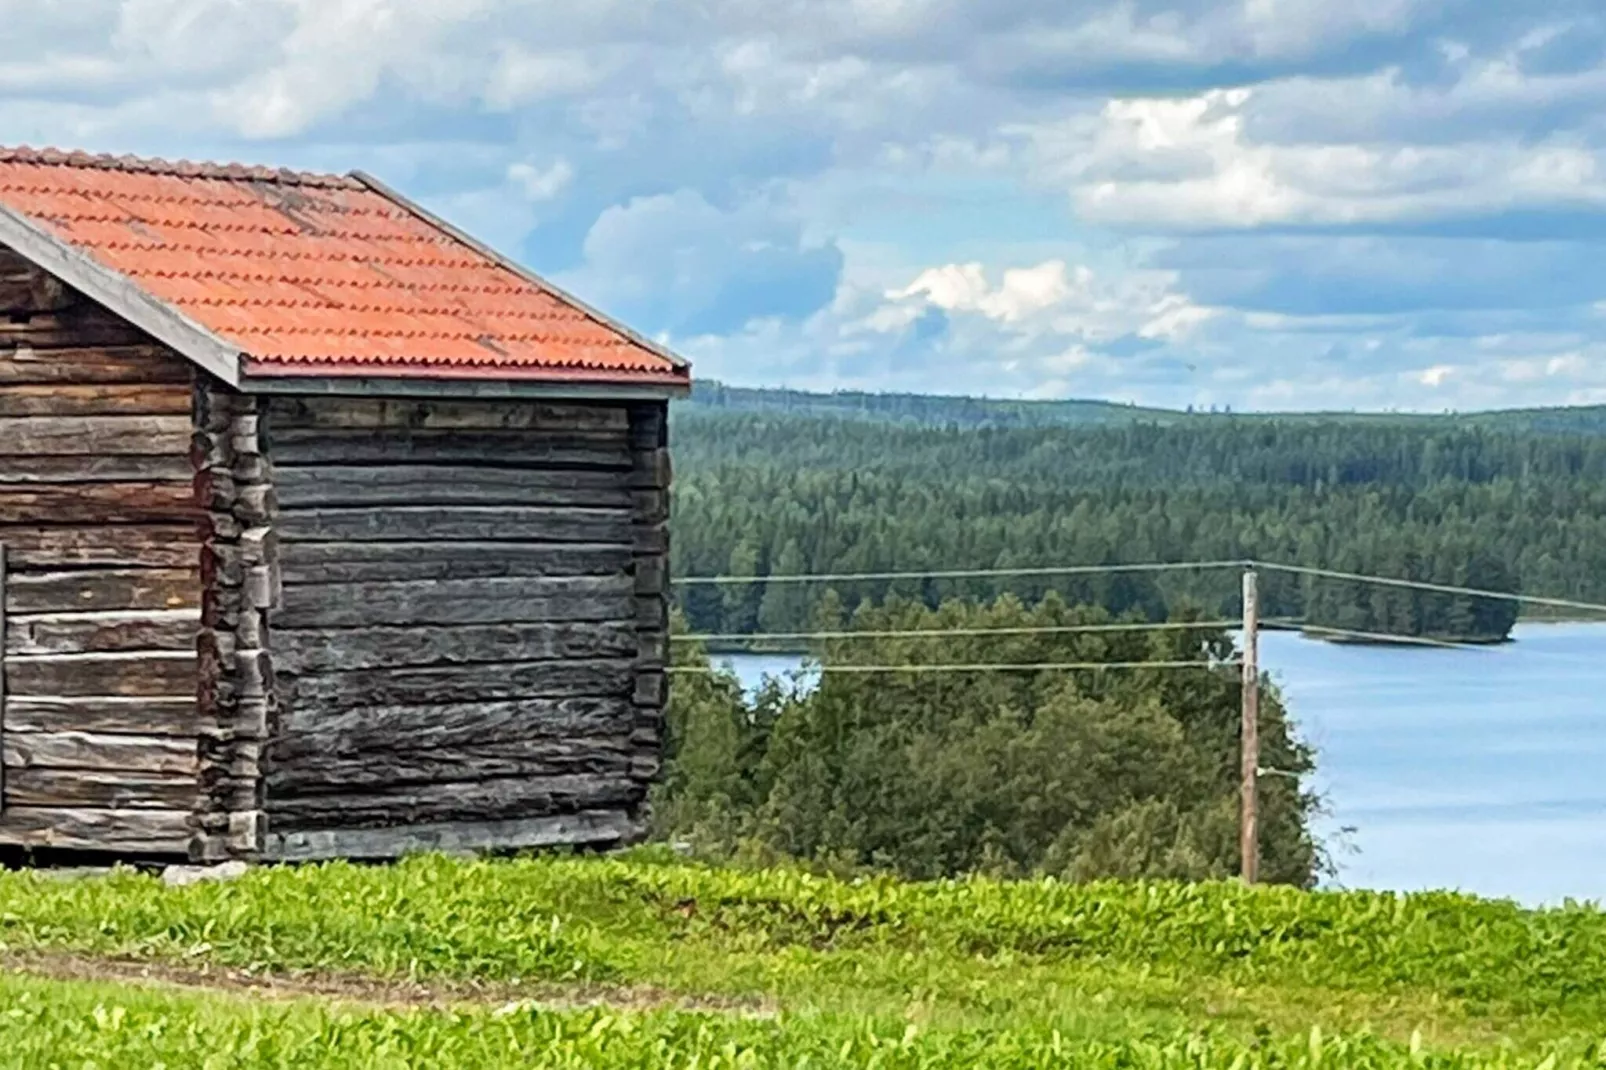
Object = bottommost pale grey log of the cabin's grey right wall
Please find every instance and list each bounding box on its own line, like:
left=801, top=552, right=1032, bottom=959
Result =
left=263, top=810, right=642, bottom=861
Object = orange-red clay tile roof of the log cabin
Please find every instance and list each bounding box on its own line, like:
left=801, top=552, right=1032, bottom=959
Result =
left=0, top=148, right=689, bottom=384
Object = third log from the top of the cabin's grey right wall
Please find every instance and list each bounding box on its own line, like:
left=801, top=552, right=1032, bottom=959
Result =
left=275, top=464, right=631, bottom=509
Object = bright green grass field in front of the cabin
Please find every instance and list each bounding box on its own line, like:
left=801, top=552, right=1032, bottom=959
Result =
left=0, top=855, right=1606, bottom=1070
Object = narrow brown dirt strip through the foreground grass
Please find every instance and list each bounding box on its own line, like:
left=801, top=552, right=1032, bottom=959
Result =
left=0, top=951, right=776, bottom=1017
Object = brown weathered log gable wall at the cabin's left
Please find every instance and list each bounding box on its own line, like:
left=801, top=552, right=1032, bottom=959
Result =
left=0, top=247, right=201, bottom=855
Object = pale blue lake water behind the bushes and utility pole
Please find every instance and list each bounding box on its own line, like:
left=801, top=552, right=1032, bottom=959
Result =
left=718, top=623, right=1606, bottom=905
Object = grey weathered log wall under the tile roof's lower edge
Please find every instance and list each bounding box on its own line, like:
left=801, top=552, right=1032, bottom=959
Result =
left=263, top=397, right=668, bottom=858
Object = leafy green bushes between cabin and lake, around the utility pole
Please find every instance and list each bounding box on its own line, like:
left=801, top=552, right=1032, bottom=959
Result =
left=654, top=594, right=1322, bottom=887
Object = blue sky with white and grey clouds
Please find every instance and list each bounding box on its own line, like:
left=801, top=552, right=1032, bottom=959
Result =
left=0, top=0, right=1606, bottom=411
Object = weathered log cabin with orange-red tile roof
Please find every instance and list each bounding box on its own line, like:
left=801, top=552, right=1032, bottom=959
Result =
left=0, top=149, right=691, bottom=863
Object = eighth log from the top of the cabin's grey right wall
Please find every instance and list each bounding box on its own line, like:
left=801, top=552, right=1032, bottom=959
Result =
left=279, top=659, right=634, bottom=710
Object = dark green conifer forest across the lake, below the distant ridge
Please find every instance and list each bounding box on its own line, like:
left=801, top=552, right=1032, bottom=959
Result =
left=673, top=406, right=1606, bottom=639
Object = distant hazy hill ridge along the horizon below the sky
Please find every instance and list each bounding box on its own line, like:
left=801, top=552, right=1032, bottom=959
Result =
left=678, top=381, right=1606, bottom=434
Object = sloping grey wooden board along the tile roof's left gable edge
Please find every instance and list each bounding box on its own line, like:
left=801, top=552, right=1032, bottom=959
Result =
left=0, top=197, right=243, bottom=386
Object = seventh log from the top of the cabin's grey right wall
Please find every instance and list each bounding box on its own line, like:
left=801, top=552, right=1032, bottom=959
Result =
left=273, top=622, right=636, bottom=673
